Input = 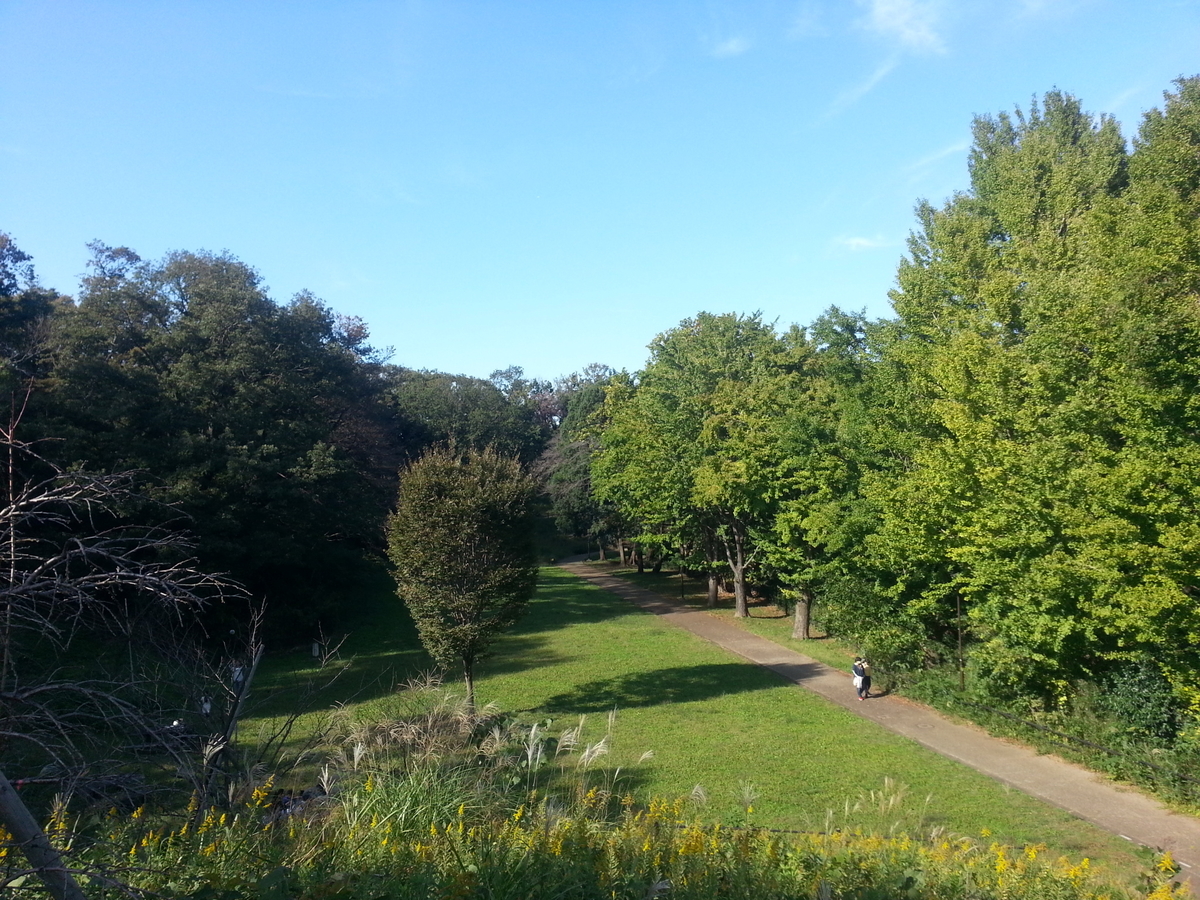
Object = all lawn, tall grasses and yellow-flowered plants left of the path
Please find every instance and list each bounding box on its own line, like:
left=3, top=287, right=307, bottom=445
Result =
left=14, top=569, right=1170, bottom=900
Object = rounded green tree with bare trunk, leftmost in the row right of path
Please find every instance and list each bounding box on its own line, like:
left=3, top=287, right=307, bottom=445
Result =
left=592, top=313, right=790, bottom=616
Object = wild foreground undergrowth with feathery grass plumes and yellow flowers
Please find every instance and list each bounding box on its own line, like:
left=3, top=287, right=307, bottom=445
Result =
left=32, top=685, right=1186, bottom=900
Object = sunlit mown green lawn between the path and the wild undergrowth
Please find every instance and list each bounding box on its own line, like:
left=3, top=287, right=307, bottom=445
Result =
left=244, top=569, right=1147, bottom=872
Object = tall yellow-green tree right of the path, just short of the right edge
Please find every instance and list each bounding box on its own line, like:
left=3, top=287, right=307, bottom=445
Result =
left=868, top=92, right=1127, bottom=696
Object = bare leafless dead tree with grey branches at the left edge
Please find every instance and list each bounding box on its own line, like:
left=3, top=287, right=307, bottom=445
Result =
left=0, top=458, right=238, bottom=900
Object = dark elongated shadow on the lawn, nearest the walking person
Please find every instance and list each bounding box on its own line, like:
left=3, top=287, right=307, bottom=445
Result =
left=540, top=662, right=772, bottom=713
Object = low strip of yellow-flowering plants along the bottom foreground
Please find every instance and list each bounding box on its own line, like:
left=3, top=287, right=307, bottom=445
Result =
left=88, top=801, right=1187, bottom=900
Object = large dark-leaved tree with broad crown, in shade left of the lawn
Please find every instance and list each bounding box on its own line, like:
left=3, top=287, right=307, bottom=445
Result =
left=43, top=245, right=400, bottom=637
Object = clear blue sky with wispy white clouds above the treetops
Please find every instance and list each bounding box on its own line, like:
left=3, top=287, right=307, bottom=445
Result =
left=0, top=0, right=1200, bottom=378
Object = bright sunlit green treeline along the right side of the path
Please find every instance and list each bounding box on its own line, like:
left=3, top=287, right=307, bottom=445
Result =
left=566, top=78, right=1200, bottom=742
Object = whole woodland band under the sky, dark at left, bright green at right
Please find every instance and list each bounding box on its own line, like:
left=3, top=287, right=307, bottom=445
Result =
left=0, top=79, right=1200, bottom=825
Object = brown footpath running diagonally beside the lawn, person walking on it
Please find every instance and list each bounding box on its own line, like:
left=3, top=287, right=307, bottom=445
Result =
left=559, top=560, right=1200, bottom=875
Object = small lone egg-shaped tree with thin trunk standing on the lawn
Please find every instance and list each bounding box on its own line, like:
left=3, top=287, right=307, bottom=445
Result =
left=388, top=448, right=538, bottom=706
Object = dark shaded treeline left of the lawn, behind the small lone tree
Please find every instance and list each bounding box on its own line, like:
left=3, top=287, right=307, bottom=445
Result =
left=0, top=235, right=610, bottom=640
